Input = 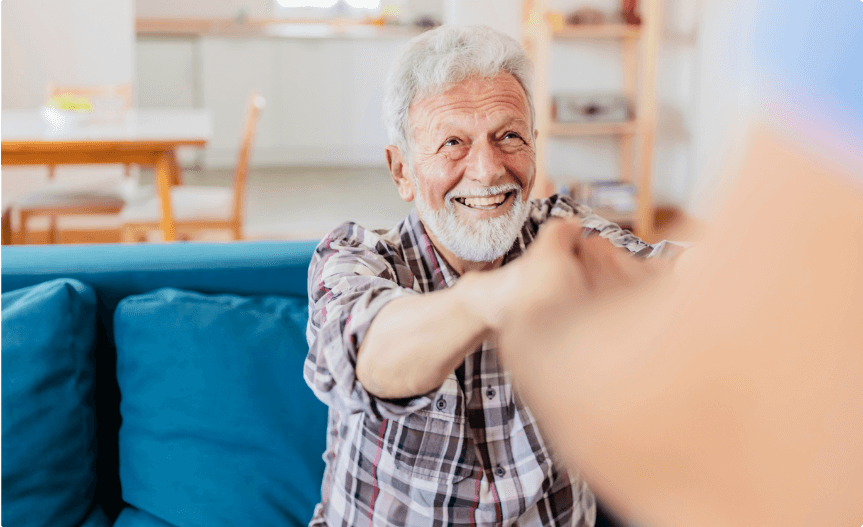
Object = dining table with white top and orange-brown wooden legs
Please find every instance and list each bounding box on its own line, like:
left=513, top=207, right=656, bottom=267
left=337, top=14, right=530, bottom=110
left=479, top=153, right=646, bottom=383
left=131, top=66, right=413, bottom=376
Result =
left=0, top=109, right=213, bottom=241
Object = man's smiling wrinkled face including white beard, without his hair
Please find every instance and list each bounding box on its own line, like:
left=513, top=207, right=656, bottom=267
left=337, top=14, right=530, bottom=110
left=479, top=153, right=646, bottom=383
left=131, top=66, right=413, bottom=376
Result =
left=402, top=73, right=536, bottom=267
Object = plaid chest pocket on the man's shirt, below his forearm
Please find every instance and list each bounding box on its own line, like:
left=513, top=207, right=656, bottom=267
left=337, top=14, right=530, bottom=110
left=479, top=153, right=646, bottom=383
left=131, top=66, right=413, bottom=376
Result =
left=388, top=376, right=477, bottom=483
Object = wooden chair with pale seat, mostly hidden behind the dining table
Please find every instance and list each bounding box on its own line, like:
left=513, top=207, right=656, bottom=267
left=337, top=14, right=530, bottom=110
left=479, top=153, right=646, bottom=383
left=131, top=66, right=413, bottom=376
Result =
left=17, top=84, right=137, bottom=243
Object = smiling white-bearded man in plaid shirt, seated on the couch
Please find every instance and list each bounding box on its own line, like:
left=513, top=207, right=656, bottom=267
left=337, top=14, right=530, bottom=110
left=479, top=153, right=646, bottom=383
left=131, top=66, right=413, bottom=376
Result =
left=304, top=26, right=676, bottom=526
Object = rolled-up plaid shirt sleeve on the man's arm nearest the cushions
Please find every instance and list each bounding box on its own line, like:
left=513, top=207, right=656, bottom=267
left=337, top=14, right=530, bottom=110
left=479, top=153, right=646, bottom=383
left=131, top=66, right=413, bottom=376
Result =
left=303, top=224, right=432, bottom=419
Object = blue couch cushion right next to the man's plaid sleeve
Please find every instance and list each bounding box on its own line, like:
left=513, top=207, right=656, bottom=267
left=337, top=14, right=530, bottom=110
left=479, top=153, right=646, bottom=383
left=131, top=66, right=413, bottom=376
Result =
left=114, top=289, right=327, bottom=527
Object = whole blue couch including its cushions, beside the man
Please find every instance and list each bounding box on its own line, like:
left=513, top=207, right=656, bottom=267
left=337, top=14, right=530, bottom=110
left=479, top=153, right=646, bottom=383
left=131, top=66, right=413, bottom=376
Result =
left=0, top=242, right=327, bottom=527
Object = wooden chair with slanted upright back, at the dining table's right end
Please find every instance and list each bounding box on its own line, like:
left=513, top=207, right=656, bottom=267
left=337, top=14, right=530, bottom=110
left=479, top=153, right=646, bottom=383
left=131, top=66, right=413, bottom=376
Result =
left=120, top=93, right=266, bottom=242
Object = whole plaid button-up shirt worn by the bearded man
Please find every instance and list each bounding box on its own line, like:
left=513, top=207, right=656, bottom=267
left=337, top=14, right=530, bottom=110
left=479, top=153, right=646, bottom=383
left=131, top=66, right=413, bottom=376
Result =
left=304, top=197, right=662, bottom=527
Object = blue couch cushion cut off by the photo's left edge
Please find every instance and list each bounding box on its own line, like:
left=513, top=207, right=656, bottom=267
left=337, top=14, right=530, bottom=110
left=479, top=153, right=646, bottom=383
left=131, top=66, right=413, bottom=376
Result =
left=0, top=279, right=96, bottom=527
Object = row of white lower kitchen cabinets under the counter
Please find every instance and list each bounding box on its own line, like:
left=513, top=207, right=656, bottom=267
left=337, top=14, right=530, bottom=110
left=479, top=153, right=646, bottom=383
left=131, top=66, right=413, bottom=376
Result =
left=136, top=37, right=408, bottom=168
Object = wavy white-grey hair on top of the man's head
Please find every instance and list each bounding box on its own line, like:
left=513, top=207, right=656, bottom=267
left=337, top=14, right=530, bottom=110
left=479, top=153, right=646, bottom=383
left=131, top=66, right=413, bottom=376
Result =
left=383, top=25, right=536, bottom=157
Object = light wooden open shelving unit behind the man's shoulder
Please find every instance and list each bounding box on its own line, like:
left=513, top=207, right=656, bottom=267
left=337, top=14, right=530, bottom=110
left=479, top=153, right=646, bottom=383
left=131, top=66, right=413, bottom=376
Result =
left=523, top=0, right=661, bottom=240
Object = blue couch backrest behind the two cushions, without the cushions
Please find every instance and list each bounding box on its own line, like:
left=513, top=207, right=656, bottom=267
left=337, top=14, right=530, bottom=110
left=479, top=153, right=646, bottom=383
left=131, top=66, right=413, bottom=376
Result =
left=0, top=241, right=317, bottom=520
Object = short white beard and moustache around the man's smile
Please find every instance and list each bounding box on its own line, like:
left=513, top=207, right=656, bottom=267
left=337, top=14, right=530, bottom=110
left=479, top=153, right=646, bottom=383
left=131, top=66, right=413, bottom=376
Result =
left=414, top=182, right=530, bottom=262
